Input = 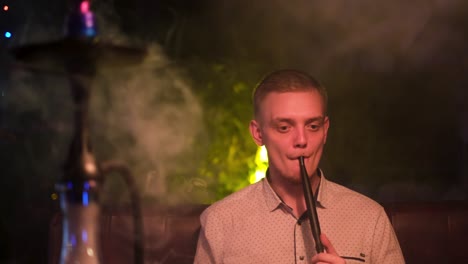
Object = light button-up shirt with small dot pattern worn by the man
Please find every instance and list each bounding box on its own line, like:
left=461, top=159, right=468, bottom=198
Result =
left=195, top=174, right=404, bottom=264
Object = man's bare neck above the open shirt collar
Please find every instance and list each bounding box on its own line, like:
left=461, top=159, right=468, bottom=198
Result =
left=268, top=170, right=320, bottom=218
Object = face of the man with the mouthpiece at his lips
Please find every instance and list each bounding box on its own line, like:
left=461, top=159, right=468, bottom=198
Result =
left=250, top=91, right=329, bottom=184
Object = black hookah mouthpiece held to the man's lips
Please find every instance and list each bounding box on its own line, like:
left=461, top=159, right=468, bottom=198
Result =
left=299, top=156, right=324, bottom=253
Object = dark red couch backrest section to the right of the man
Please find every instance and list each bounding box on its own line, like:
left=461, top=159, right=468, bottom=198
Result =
left=384, top=201, right=468, bottom=264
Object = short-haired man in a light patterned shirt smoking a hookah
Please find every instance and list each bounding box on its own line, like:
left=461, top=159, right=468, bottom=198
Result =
left=195, top=70, right=404, bottom=264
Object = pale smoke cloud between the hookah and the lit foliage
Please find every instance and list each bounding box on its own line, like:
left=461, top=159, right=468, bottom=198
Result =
left=91, top=45, right=203, bottom=202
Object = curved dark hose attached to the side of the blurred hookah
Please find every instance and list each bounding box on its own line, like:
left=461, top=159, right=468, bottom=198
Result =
left=101, top=161, right=144, bottom=264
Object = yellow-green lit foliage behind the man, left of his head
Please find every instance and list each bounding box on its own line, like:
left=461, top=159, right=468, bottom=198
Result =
left=181, top=60, right=266, bottom=202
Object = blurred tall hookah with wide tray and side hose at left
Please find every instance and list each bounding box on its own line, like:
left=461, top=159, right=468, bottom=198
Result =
left=12, top=0, right=145, bottom=264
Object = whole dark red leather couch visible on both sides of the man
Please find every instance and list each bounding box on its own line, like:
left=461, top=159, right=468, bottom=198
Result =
left=49, top=201, right=468, bottom=264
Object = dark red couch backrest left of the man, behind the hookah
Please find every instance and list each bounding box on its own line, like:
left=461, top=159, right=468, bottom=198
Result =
left=49, top=205, right=207, bottom=264
